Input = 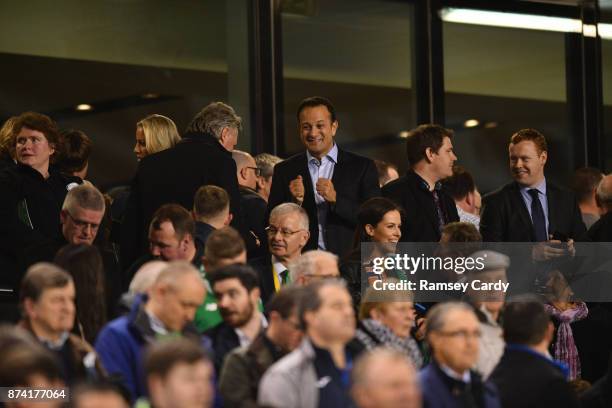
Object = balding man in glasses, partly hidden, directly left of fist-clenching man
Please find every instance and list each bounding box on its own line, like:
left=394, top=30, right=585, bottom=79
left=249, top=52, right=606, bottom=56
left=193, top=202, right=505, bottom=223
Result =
left=232, top=150, right=268, bottom=259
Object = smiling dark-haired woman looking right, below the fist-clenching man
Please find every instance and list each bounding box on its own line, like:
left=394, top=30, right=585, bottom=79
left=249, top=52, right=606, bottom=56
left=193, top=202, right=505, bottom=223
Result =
left=340, top=197, right=403, bottom=308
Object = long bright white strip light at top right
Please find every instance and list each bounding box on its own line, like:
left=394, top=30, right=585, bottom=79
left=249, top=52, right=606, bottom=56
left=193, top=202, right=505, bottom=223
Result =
left=440, top=7, right=580, bottom=33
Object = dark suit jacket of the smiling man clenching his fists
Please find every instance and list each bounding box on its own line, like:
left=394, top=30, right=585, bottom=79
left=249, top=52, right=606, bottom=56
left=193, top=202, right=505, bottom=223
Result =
left=268, top=148, right=380, bottom=256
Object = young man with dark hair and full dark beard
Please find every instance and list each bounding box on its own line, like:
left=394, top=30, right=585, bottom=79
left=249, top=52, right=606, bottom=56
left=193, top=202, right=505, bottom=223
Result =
left=204, top=264, right=268, bottom=376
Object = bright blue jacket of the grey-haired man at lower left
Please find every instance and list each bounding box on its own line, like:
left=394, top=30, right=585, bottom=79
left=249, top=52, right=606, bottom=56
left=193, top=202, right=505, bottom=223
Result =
left=95, top=295, right=204, bottom=400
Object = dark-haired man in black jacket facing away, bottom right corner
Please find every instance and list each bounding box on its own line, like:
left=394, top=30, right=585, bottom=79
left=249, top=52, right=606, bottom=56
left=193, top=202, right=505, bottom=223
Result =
left=490, top=298, right=579, bottom=408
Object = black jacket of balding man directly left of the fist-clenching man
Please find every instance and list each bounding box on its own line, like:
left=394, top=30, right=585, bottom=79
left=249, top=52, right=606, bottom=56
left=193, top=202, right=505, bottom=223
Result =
left=240, top=186, right=268, bottom=259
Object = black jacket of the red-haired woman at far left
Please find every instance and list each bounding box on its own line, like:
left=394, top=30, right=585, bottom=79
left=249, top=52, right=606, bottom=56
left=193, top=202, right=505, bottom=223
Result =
left=0, top=164, right=82, bottom=288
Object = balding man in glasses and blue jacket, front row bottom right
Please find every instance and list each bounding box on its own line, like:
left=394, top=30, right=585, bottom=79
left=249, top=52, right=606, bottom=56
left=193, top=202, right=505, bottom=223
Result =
left=419, top=302, right=501, bottom=408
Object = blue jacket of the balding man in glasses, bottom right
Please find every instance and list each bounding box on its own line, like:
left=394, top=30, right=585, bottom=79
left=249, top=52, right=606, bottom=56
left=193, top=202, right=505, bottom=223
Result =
left=419, top=361, right=501, bottom=408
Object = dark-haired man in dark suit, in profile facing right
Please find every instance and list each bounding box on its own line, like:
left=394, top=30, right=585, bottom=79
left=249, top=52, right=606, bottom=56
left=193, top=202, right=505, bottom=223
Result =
left=382, top=125, right=459, bottom=242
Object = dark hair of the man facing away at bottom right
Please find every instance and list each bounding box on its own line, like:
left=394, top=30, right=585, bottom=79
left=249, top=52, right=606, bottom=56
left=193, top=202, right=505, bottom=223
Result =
left=503, top=296, right=550, bottom=345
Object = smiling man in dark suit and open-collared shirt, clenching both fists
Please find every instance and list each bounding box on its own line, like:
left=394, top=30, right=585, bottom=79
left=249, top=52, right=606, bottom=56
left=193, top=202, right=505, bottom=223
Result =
left=268, top=96, right=380, bottom=256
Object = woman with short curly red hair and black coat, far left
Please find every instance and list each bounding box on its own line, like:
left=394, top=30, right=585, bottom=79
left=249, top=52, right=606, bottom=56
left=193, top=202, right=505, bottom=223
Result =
left=0, top=112, right=81, bottom=298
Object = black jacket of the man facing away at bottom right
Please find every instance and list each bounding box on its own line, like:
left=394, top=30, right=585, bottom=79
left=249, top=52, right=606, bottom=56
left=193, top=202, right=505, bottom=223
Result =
left=489, top=347, right=579, bottom=408
